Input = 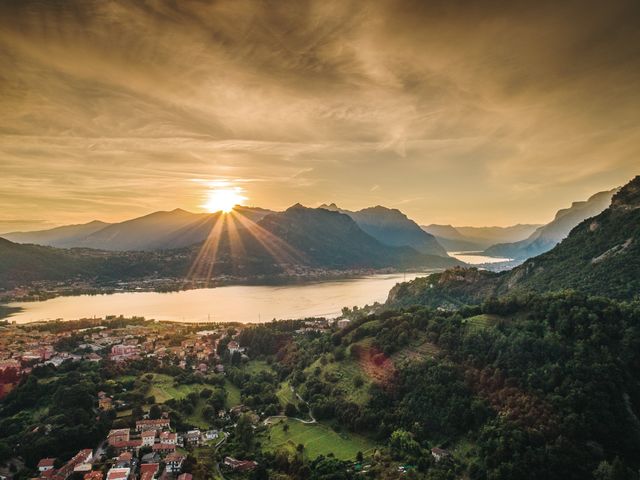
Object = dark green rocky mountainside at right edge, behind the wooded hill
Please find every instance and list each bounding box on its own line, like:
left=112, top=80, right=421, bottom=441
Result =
left=388, top=176, right=640, bottom=307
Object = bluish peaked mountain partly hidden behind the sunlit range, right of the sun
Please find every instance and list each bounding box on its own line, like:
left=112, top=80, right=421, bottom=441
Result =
left=319, top=203, right=448, bottom=257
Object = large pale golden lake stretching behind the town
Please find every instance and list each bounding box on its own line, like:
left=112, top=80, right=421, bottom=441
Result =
left=9, top=272, right=431, bottom=323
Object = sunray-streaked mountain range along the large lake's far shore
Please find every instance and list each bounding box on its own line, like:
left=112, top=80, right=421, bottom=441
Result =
left=0, top=205, right=462, bottom=286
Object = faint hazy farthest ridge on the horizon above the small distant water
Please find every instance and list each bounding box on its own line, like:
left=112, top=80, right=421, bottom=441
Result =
left=422, top=224, right=540, bottom=252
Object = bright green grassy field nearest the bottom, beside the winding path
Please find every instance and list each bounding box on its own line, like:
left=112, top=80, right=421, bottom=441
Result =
left=262, top=420, right=376, bottom=460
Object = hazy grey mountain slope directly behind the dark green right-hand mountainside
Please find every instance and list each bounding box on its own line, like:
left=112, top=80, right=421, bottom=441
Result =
left=484, top=189, right=618, bottom=260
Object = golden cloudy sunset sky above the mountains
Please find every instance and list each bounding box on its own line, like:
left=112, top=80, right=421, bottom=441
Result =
left=0, top=0, right=640, bottom=232
